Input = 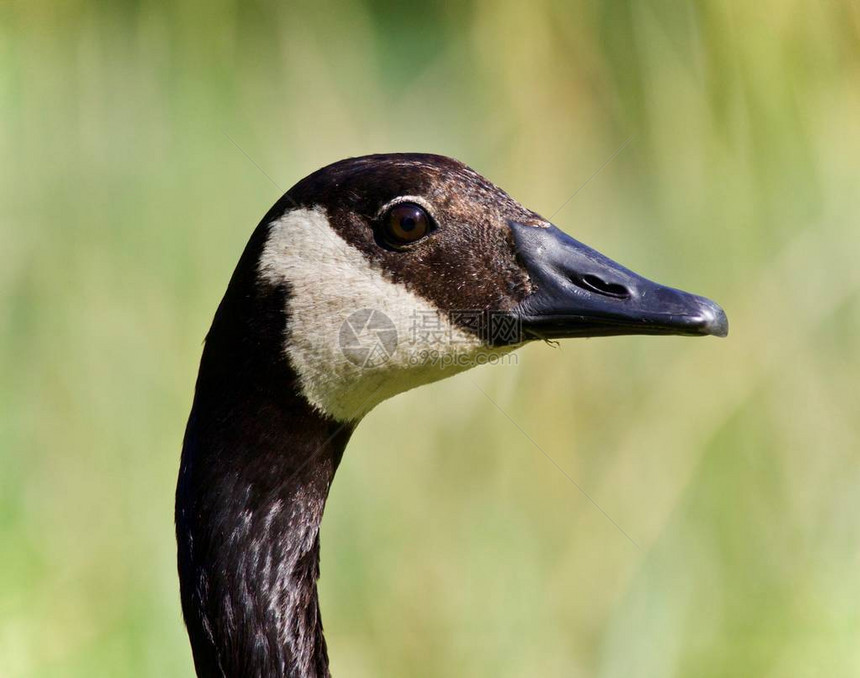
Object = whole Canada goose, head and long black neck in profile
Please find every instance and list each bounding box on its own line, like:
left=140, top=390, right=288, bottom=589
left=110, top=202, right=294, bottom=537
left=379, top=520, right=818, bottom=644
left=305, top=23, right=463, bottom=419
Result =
left=175, top=153, right=728, bottom=678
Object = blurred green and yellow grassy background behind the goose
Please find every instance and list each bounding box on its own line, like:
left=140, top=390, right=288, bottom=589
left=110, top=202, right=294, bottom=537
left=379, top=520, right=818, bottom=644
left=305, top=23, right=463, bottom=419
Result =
left=0, top=0, right=860, bottom=678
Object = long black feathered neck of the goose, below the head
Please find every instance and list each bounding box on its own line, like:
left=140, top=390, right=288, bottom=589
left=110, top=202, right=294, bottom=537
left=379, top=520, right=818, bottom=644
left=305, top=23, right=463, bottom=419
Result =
left=176, top=214, right=352, bottom=678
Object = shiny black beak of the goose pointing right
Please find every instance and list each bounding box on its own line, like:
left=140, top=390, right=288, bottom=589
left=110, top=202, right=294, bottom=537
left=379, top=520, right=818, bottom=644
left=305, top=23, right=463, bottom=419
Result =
left=510, top=221, right=729, bottom=339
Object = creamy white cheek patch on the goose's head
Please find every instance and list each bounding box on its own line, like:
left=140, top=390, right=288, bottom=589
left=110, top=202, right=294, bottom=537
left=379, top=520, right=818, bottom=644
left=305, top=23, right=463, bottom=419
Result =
left=258, top=208, right=512, bottom=421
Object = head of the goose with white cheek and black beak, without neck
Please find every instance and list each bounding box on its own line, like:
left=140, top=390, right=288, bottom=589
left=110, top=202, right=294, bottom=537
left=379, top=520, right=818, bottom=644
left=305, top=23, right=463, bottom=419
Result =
left=252, top=154, right=727, bottom=421
